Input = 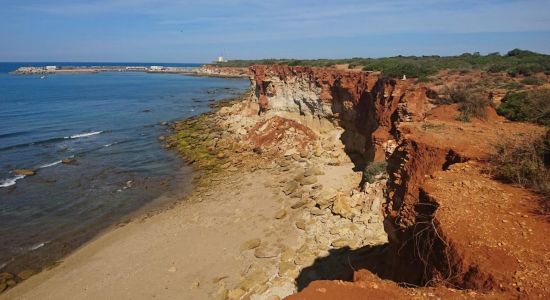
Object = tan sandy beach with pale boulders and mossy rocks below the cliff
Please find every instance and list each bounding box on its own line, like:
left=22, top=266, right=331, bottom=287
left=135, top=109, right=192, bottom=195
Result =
left=0, top=88, right=386, bottom=299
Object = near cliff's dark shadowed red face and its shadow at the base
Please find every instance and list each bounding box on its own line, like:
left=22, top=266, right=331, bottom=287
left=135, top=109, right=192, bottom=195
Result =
left=296, top=141, right=488, bottom=291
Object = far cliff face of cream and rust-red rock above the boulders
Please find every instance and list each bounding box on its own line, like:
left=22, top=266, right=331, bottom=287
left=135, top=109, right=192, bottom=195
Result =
left=250, top=65, right=436, bottom=161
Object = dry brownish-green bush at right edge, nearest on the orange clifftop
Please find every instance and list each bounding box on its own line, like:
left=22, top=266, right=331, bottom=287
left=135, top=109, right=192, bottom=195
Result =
left=492, top=130, right=550, bottom=196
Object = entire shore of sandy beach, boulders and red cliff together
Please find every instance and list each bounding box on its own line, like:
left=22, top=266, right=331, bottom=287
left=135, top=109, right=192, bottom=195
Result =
left=0, top=66, right=550, bottom=299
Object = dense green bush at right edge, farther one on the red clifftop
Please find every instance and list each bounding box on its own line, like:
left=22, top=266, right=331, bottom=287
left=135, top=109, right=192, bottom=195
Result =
left=497, top=88, right=550, bottom=125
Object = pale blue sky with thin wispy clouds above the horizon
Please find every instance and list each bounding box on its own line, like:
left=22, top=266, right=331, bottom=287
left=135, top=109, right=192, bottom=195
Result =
left=0, top=0, right=550, bottom=63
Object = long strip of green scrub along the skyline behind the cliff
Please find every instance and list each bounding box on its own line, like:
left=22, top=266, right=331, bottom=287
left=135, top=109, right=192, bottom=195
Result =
left=223, top=49, right=550, bottom=80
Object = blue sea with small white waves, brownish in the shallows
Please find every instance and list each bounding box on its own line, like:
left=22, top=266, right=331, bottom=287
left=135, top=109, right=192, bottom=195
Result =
left=0, top=62, right=250, bottom=272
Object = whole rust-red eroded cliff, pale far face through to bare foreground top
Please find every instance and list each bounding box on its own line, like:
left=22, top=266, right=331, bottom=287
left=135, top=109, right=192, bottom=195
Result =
left=251, top=66, right=550, bottom=299
